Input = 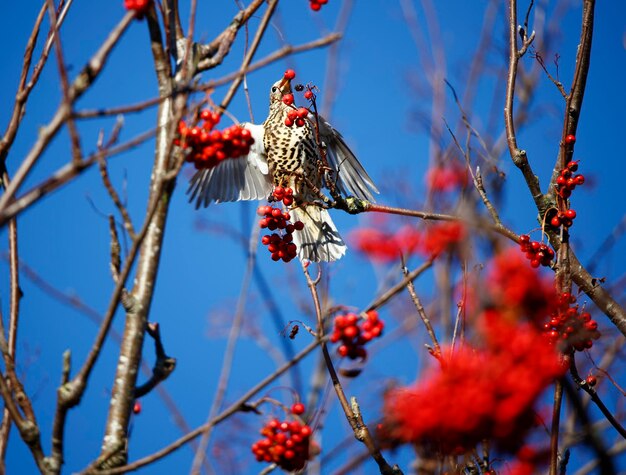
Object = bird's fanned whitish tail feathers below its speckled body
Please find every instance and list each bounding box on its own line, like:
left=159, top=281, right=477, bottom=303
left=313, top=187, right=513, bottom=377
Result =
left=290, top=205, right=347, bottom=262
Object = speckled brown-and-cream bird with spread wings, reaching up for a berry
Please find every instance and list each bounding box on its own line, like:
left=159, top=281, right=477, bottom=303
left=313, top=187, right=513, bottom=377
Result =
left=187, top=73, right=379, bottom=262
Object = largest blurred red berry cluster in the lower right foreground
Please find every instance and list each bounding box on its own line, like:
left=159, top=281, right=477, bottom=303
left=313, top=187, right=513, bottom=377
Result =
left=381, top=318, right=566, bottom=456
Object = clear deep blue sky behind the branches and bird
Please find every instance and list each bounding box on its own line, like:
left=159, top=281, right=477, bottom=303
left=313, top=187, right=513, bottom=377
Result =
left=0, top=0, right=626, bottom=473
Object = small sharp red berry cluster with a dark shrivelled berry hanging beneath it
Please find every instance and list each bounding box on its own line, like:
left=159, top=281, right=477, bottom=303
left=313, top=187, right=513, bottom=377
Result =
left=330, top=310, right=385, bottom=360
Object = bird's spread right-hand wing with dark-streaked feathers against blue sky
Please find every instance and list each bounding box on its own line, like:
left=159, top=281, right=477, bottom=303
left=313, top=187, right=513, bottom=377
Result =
left=309, top=115, right=378, bottom=205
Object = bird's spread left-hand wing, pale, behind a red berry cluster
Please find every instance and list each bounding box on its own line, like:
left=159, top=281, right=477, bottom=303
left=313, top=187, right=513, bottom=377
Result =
left=187, top=122, right=272, bottom=208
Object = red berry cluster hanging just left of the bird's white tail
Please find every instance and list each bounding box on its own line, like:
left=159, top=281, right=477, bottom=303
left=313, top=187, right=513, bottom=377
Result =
left=257, top=205, right=304, bottom=262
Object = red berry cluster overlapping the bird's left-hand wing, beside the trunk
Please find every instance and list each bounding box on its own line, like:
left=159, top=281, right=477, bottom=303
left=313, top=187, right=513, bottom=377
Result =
left=174, top=110, right=254, bottom=169
